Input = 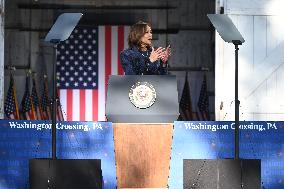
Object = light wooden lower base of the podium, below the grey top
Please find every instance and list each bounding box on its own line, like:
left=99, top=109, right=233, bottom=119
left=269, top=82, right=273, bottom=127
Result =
left=113, top=123, right=173, bottom=188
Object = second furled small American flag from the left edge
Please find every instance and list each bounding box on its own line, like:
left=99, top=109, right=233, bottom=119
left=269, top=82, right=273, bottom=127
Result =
left=21, top=76, right=36, bottom=120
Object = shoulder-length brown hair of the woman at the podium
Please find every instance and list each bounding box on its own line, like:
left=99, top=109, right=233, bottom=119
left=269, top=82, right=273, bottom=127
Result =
left=128, top=21, right=150, bottom=49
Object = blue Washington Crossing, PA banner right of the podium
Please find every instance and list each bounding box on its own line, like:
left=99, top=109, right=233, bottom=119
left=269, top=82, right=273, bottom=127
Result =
left=169, top=121, right=284, bottom=189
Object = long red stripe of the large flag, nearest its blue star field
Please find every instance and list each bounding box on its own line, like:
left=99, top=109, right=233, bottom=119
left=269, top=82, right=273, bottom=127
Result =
left=105, top=26, right=111, bottom=94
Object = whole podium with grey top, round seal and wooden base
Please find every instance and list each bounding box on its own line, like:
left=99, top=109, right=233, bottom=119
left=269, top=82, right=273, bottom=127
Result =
left=106, top=75, right=179, bottom=189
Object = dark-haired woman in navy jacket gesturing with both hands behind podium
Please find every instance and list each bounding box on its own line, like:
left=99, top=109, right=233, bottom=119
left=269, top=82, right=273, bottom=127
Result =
left=120, top=21, right=171, bottom=75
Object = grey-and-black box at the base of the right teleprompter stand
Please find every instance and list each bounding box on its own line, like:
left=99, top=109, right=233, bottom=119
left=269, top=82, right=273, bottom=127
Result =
left=183, top=159, right=261, bottom=189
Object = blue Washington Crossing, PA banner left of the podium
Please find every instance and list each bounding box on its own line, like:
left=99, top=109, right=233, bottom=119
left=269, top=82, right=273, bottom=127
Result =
left=0, top=120, right=116, bottom=189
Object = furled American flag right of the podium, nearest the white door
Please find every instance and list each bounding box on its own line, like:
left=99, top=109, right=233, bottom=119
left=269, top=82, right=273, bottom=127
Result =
left=197, top=75, right=210, bottom=121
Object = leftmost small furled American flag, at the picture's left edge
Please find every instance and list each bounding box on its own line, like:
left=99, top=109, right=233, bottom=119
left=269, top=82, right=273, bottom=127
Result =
left=4, top=74, right=20, bottom=119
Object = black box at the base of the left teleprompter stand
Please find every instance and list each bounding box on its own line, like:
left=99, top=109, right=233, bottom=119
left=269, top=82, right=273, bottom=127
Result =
left=29, top=159, right=103, bottom=189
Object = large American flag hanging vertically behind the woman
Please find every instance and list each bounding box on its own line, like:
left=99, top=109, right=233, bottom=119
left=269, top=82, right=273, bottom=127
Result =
left=57, top=26, right=129, bottom=121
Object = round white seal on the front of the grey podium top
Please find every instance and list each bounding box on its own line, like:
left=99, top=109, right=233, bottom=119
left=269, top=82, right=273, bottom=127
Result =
left=128, top=82, right=157, bottom=109
